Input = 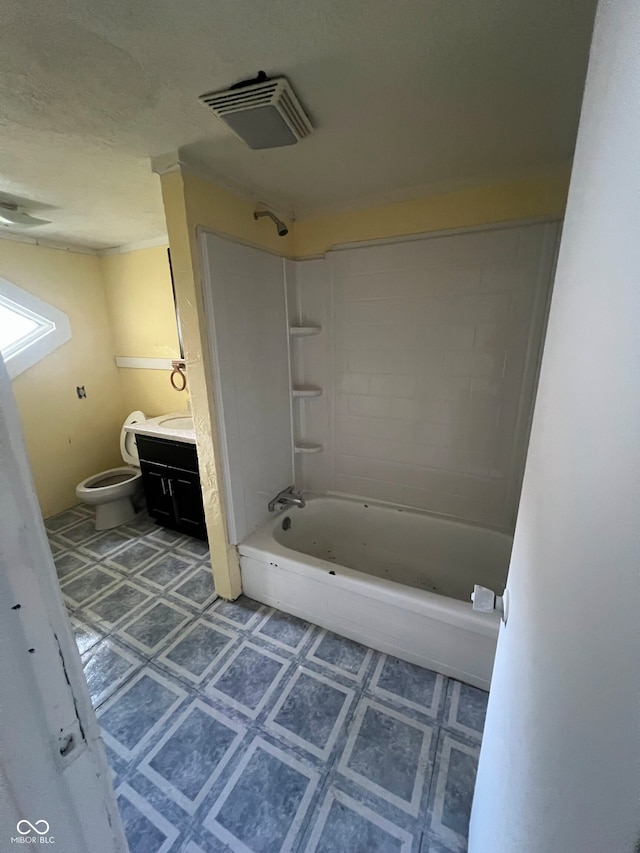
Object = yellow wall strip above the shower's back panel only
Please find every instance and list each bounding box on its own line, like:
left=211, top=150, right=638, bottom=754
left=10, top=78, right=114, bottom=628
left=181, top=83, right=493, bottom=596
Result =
left=294, top=168, right=570, bottom=258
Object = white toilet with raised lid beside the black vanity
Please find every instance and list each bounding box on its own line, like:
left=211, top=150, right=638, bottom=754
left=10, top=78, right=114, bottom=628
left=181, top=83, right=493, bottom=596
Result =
left=76, top=412, right=147, bottom=530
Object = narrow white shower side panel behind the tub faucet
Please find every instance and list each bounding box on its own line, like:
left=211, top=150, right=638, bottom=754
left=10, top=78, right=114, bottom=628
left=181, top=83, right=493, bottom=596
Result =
left=201, top=233, right=293, bottom=544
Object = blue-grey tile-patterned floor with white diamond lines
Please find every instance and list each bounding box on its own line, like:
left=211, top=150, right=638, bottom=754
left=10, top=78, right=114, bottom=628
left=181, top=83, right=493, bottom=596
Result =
left=46, top=508, right=487, bottom=853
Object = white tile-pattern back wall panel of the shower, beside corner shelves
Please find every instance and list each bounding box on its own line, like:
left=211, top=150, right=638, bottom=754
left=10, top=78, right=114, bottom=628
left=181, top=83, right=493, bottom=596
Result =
left=289, top=223, right=558, bottom=529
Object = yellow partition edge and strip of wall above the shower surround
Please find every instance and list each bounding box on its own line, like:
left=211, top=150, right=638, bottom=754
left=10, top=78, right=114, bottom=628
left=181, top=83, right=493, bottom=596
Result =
left=161, top=161, right=569, bottom=598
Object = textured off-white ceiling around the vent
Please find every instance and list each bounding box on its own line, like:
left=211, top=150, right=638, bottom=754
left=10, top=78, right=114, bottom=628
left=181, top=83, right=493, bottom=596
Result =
left=0, top=0, right=595, bottom=248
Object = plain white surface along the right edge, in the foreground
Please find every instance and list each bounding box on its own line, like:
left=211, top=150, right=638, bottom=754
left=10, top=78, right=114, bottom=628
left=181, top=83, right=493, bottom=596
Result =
left=469, top=0, right=640, bottom=853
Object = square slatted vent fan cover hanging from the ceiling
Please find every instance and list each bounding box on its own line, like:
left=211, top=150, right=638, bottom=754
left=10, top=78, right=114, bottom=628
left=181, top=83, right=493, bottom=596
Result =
left=198, top=71, right=313, bottom=149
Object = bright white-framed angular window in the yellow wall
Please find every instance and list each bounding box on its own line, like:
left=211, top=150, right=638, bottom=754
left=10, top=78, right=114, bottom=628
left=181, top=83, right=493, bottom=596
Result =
left=0, top=278, right=71, bottom=379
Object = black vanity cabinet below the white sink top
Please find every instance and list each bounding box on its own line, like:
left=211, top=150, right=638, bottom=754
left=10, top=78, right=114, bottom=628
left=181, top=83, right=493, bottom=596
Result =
left=136, top=435, right=207, bottom=539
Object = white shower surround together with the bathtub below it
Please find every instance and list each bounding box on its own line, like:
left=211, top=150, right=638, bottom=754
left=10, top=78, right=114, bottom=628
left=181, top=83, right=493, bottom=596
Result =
left=203, top=223, right=559, bottom=689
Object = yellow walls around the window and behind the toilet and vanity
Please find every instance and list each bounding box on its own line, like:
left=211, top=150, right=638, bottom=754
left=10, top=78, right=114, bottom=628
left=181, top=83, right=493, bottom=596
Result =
left=0, top=240, right=188, bottom=518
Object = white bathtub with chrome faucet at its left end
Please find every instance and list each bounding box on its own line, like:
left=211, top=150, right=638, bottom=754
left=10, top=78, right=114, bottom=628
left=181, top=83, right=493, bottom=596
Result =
left=238, top=495, right=512, bottom=690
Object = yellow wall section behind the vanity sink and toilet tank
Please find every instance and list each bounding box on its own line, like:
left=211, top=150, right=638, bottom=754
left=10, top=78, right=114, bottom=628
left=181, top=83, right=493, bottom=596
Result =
left=100, top=246, right=189, bottom=417
